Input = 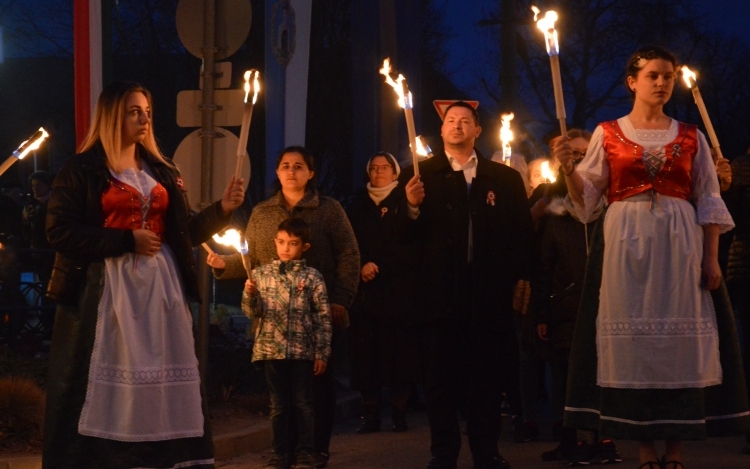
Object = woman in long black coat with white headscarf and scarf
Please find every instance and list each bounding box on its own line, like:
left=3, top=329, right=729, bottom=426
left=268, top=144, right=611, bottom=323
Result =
left=347, top=152, right=416, bottom=434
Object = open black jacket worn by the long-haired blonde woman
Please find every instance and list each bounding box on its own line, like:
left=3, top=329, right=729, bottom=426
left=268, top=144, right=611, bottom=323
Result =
left=47, top=144, right=230, bottom=304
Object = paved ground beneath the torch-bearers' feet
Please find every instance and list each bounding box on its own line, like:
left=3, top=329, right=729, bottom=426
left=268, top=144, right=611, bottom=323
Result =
left=217, top=412, right=750, bottom=469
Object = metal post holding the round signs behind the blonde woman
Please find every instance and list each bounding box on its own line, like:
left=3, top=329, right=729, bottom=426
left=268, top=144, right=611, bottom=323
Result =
left=196, top=0, right=216, bottom=383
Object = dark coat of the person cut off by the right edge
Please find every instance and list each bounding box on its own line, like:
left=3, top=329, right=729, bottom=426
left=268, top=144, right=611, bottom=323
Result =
left=722, top=155, right=750, bottom=286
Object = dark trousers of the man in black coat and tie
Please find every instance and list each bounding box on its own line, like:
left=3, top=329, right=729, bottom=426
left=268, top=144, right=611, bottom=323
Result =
left=418, top=313, right=518, bottom=463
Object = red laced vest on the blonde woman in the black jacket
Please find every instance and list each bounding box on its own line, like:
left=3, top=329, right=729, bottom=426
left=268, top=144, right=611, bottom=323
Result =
left=101, top=178, right=169, bottom=240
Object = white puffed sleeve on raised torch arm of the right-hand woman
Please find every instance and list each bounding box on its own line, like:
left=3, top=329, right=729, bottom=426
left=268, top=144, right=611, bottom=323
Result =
left=573, top=126, right=609, bottom=223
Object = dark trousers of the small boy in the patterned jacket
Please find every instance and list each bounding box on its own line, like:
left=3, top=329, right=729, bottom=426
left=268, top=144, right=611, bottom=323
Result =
left=265, top=360, right=315, bottom=456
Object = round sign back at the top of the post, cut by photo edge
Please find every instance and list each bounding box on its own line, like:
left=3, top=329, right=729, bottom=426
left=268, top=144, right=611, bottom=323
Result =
left=175, top=0, right=253, bottom=60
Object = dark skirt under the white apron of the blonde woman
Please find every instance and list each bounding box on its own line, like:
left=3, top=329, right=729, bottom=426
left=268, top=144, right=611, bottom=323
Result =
left=42, top=263, right=214, bottom=469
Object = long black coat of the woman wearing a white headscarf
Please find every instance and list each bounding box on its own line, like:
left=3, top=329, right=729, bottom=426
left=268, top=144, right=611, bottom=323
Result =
left=347, top=189, right=418, bottom=393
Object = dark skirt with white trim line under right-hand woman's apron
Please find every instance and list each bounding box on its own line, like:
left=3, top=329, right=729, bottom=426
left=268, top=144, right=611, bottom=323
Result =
left=565, top=214, right=750, bottom=440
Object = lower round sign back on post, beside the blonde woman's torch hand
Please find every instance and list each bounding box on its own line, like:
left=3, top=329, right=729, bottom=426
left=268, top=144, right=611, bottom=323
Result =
left=174, top=128, right=250, bottom=210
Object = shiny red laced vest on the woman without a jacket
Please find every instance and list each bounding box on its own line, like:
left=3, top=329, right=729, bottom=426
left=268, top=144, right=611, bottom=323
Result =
left=601, top=121, right=698, bottom=204
